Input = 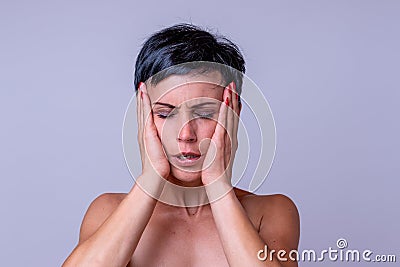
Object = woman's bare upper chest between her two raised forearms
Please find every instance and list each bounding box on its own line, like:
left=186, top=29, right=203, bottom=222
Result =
left=129, top=217, right=228, bottom=267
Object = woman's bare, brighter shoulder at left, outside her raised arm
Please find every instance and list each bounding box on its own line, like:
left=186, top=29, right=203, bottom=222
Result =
left=79, top=193, right=127, bottom=243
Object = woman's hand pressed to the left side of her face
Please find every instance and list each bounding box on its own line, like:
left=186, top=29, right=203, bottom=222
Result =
left=137, top=82, right=170, bottom=179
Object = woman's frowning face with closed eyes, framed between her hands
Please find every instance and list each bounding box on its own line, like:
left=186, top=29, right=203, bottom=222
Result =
left=148, top=72, right=224, bottom=186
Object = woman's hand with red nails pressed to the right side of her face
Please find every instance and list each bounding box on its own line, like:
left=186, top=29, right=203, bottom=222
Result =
left=201, top=82, right=240, bottom=185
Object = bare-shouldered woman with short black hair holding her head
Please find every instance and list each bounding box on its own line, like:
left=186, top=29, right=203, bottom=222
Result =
left=63, top=24, right=299, bottom=266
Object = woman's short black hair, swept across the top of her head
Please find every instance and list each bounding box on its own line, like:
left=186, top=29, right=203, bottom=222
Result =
left=134, top=24, right=246, bottom=97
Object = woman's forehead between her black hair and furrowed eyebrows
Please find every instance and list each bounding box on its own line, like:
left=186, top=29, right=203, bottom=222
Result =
left=147, top=72, right=224, bottom=106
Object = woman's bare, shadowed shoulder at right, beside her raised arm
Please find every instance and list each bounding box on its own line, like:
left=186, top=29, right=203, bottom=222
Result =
left=237, top=188, right=300, bottom=249
